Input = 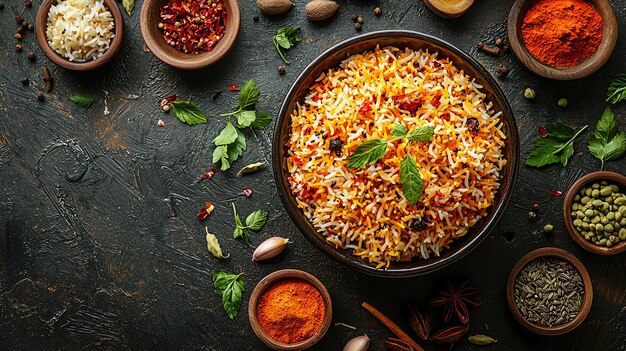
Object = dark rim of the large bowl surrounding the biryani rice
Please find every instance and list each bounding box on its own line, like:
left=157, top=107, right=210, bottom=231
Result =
left=272, top=30, right=519, bottom=277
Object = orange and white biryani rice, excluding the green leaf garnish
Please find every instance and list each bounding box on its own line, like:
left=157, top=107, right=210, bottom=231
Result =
left=286, top=47, right=506, bottom=268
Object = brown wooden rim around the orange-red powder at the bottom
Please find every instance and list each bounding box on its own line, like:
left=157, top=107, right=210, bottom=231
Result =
left=248, top=269, right=333, bottom=351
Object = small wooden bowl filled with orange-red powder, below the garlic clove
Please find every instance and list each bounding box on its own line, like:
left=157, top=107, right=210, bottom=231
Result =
left=248, top=269, right=332, bottom=351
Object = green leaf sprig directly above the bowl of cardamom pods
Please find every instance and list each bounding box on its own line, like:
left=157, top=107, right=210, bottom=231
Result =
left=587, top=107, right=626, bottom=169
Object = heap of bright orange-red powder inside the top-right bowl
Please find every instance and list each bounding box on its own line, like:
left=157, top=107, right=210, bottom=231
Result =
left=522, top=0, right=603, bottom=67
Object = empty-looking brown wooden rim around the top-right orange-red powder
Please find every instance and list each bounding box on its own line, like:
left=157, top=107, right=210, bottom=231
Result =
left=507, top=0, right=618, bottom=80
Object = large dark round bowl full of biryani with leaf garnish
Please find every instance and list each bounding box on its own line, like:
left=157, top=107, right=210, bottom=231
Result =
left=272, top=31, right=519, bottom=277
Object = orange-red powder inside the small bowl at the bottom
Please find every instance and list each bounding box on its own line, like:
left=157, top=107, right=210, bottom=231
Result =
left=256, top=279, right=326, bottom=344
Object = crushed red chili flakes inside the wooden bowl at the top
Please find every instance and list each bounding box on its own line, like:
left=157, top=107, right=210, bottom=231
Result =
left=159, top=0, right=227, bottom=54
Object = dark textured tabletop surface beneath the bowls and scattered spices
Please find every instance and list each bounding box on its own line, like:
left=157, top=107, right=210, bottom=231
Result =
left=0, top=0, right=626, bottom=351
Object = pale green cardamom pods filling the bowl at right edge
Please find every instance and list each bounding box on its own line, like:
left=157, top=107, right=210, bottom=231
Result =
left=571, top=180, right=626, bottom=247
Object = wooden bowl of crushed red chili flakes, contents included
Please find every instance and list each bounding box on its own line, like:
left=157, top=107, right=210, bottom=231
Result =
left=140, top=0, right=240, bottom=70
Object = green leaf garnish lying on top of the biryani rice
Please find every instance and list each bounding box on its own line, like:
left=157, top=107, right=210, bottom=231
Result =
left=346, top=124, right=435, bottom=205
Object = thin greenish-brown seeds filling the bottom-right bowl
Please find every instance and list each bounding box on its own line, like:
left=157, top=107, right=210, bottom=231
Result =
left=514, top=258, right=584, bottom=327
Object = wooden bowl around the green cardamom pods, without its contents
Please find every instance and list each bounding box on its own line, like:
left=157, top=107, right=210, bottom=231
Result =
left=563, top=171, right=626, bottom=255
